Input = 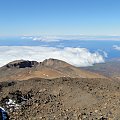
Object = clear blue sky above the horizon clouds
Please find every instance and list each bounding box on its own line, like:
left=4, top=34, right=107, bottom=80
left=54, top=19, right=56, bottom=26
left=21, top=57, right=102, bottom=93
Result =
left=0, top=0, right=120, bottom=36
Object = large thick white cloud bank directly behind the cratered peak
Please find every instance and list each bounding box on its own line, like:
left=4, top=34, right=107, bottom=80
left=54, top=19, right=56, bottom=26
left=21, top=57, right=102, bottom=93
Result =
left=0, top=46, right=104, bottom=67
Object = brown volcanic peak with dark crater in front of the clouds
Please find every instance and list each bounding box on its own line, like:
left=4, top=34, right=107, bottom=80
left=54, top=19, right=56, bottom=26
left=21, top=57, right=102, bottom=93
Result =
left=0, top=59, right=103, bottom=81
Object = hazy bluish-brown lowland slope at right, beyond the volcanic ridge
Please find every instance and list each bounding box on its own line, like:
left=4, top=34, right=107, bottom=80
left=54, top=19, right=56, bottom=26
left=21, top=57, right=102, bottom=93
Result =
left=81, top=58, right=120, bottom=79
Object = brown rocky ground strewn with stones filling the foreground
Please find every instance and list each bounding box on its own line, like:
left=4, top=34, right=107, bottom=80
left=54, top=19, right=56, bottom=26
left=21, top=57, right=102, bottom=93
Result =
left=0, top=77, right=120, bottom=120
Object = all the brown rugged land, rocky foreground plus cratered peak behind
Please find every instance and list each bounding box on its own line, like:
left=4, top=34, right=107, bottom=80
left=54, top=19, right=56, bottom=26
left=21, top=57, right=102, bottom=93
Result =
left=0, top=59, right=120, bottom=120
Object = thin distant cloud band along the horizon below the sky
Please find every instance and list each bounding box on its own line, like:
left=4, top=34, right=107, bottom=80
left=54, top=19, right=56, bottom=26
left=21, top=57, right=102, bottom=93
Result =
left=21, top=34, right=120, bottom=42
